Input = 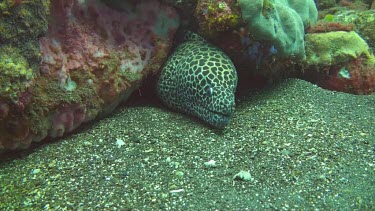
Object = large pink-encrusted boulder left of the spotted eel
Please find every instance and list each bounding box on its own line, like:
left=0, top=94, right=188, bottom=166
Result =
left=0, top=0, right=179, bottom=150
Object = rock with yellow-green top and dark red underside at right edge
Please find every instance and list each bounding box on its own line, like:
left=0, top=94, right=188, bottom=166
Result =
left=303, top=31, right=375, bottom=94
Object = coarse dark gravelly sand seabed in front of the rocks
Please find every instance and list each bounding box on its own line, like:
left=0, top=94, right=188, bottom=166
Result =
left=0, top=80, right=375, bottom=210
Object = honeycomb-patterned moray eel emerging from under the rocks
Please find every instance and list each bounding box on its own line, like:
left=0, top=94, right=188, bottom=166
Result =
left=157, top=32, right=238, bottom=129
